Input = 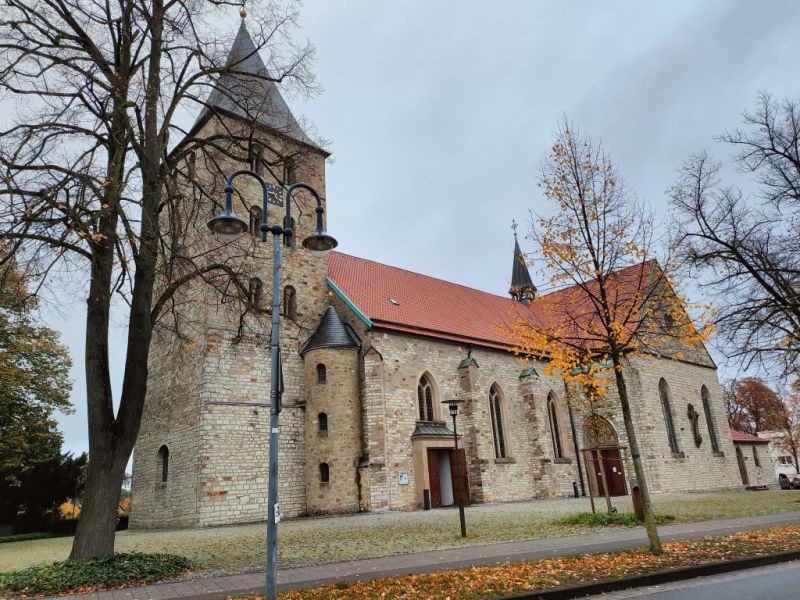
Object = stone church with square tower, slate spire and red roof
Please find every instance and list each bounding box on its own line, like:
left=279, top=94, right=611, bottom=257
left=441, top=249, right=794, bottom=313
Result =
left=130, top=22, right=739, bottom=528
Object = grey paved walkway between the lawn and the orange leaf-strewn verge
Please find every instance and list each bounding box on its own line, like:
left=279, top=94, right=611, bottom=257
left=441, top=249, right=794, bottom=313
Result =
left=40, top=512, right=800, bottom=600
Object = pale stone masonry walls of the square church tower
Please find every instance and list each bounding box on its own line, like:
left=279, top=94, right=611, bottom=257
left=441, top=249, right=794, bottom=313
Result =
left=131, top=111, right=327, bottom=527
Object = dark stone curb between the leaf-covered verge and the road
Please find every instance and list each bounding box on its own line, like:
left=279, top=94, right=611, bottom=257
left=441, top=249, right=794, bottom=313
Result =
left=498, top=550, right=800, bottom=600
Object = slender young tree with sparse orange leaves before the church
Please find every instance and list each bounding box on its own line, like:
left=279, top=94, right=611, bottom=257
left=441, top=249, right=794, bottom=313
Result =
left=511, top=121, right=707, bottom=554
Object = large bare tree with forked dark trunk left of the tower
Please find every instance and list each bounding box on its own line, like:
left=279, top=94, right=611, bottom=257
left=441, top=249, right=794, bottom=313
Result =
left=0, top=0, right=316, bottom=558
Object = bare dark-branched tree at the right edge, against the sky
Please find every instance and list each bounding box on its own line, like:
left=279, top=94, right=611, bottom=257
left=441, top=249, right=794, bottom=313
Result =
left=671, top=93, right=800, bottom=374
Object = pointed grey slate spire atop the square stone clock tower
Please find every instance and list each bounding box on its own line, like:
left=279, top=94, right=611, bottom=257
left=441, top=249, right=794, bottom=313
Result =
left=200, top=18, right=318, bottom=148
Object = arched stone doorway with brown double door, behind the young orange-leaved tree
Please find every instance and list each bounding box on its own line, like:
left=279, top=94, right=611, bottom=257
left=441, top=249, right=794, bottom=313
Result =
left=583, top=415, right=628, bottom=496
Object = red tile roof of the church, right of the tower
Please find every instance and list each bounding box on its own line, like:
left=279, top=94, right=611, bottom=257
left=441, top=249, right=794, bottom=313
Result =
left=328, top=252, right=650, bottom=349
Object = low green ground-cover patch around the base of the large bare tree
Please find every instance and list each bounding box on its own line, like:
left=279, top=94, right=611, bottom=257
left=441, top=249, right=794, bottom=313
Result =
left=0, top=552, right=197, bottom=595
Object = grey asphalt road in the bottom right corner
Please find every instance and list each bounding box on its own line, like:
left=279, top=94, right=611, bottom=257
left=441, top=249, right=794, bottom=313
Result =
left=585, top=561, right=800, bottom=600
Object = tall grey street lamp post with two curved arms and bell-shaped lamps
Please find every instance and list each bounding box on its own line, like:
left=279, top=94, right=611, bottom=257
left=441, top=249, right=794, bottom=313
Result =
left=208, top=169, right=337, bottom=600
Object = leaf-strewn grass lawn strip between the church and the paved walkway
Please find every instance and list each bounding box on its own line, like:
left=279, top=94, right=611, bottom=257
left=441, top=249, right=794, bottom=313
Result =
left=0, top=490, right=800, bottom=572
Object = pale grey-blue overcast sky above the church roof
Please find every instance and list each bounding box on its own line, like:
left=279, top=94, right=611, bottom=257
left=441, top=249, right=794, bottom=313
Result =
left=46, top=0, right=800, bottom=451
